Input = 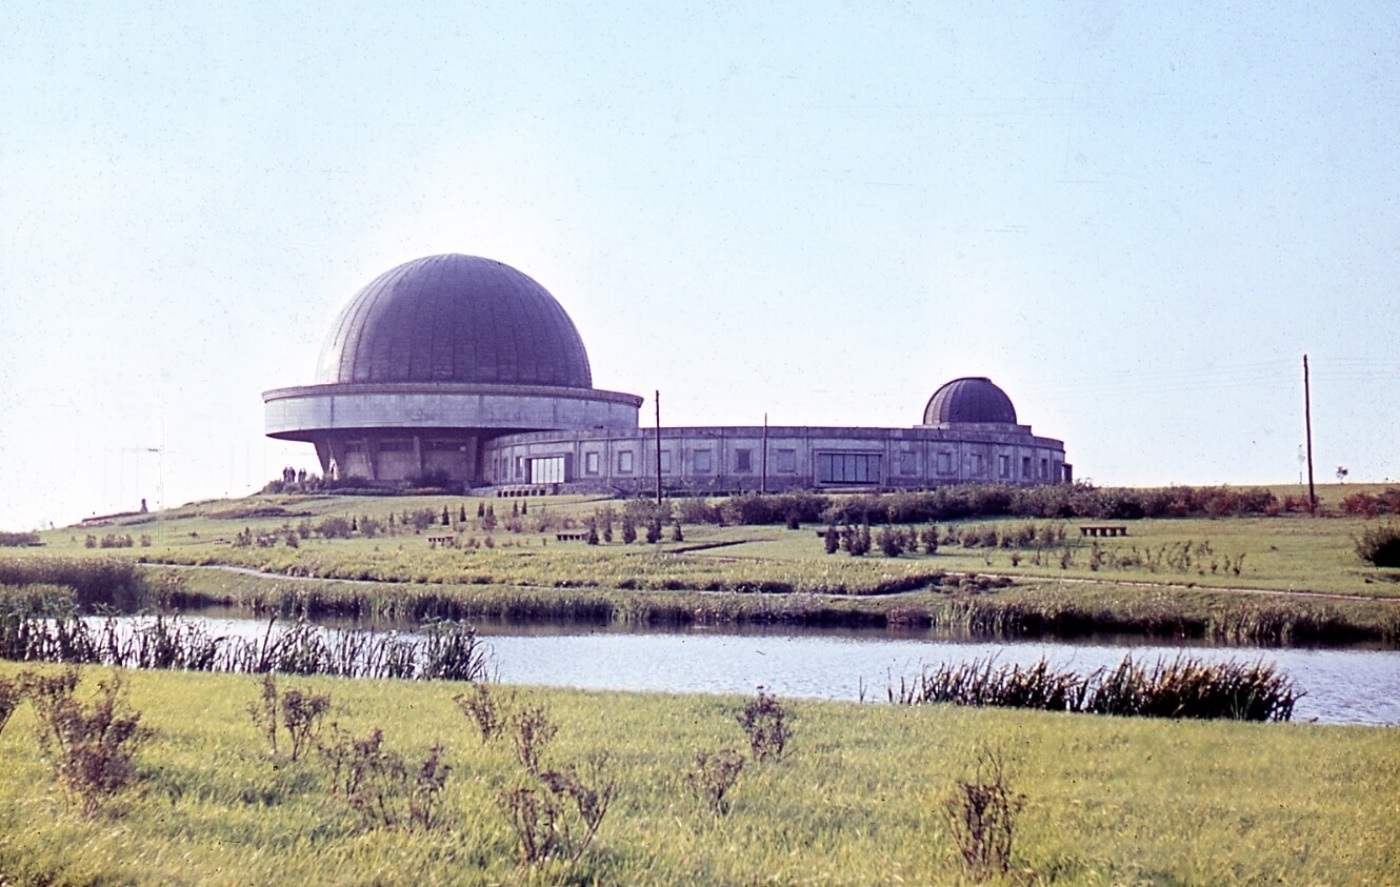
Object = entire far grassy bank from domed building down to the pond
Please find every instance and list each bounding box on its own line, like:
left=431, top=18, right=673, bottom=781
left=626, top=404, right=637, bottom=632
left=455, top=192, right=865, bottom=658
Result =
left=0, top=485, right=1400, bottom=645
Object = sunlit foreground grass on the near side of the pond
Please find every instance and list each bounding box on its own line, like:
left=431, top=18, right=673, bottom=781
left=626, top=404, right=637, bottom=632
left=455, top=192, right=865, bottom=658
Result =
left=0, top=663, right=1400, bottom=884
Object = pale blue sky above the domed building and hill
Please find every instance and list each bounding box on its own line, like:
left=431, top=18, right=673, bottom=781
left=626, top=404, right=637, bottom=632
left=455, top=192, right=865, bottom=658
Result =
left=0, top=0, right=1400, bottom=529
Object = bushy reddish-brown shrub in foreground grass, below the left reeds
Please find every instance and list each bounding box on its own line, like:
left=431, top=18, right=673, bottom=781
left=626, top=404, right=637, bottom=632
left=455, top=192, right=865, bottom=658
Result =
left=25, top=667, right=150, bottom=816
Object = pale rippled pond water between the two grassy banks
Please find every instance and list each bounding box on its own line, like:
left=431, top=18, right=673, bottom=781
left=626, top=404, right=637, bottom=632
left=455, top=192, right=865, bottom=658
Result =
left=172, top=618, right=1400, bottom=725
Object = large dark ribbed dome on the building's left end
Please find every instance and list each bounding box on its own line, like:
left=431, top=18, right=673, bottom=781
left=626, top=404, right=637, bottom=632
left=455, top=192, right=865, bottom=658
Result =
left=316, top=253, right=594, bottom=389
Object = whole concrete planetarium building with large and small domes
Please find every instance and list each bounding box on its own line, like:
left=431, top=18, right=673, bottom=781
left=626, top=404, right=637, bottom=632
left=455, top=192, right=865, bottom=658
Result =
left=263, top=255, right=1072, bottom=494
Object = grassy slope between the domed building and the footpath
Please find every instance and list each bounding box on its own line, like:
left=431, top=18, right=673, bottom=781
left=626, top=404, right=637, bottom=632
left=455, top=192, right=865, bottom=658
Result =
left=30, top=485, right=1400, bottom=597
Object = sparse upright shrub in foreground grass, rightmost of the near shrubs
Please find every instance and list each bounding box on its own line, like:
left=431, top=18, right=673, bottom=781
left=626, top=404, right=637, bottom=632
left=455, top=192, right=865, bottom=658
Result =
left=944, top=748, right=1025, bottom=880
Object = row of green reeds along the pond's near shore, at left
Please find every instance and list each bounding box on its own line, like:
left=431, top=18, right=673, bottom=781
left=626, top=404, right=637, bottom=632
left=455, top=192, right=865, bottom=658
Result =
left=0, top=611, right=489, bottom=680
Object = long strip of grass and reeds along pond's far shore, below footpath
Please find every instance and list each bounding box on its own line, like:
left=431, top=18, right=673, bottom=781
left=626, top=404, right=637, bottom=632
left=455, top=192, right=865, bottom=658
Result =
left=147, top=568, right=1400, bottom=646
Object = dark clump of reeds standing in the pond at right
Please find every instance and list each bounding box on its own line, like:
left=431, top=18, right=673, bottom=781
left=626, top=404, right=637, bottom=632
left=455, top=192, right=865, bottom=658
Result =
left=888, top=656, right=1302, bottom=721
